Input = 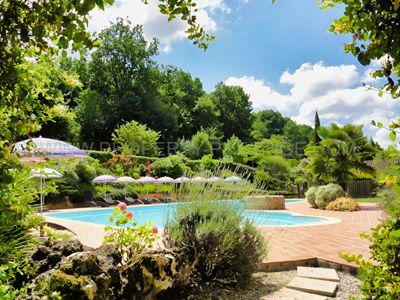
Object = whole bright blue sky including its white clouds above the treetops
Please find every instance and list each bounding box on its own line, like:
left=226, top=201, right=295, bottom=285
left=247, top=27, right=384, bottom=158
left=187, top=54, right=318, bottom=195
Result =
left=89, top=0, right=399, bottom=145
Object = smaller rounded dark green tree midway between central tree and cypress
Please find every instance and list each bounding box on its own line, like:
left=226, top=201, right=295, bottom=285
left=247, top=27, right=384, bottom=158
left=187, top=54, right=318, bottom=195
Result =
left=251, top=109, right=288, bottom=141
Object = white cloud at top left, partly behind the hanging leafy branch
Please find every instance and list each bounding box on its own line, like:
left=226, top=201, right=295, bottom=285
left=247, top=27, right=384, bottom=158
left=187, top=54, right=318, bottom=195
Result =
left=89, top=0, right=231, bottom=52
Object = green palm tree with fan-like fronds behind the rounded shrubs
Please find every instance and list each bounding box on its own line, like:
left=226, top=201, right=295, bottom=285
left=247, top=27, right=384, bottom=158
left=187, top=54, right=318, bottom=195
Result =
left=305, top=124, right=376, bottom=189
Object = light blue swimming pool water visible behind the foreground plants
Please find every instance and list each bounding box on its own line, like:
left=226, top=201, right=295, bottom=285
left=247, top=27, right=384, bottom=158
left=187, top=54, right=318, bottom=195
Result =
left=45, top=199, right=327, bottom=228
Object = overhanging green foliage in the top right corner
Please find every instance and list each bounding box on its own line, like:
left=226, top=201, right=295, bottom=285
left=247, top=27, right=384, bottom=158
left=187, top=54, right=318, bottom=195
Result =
left=321, top=0, right=400, bottom=98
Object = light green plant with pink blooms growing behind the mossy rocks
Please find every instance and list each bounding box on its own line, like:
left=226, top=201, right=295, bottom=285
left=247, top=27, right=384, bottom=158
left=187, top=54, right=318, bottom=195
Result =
left=103, top=202, right=158, bottom=262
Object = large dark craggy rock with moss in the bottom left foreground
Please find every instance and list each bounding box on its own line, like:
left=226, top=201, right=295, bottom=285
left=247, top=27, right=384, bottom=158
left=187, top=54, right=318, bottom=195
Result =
left=21, top=245, right=191, bottom=300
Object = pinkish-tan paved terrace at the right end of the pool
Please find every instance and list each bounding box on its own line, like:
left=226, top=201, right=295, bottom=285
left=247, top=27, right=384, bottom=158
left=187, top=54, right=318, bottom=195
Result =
left=261, top=201, right=383, bottom=263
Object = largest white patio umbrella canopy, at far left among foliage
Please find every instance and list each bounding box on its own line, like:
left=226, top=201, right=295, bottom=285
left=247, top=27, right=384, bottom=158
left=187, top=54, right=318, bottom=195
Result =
left=13, top=136, right=88, bottom=158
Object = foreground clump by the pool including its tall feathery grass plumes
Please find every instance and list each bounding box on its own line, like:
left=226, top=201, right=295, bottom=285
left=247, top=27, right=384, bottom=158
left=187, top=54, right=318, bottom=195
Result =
left=165, top=171, right=266, bottom=285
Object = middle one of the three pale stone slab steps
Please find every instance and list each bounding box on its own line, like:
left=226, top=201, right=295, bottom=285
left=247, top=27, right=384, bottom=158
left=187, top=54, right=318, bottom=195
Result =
left=286, top=277, right=338, bottom=297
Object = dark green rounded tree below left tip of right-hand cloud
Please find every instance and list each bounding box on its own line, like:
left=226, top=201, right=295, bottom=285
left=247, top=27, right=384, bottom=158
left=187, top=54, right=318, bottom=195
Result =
left=210, top=83, right=253, bottom=141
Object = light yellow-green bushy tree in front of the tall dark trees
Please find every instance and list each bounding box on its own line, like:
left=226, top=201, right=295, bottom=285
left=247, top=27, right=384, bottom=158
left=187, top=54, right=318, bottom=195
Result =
left=113, top=121, right=160, bottom=156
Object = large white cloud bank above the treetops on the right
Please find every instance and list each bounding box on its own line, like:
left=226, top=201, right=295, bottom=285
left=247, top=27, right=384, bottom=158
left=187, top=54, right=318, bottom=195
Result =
left=225, top=62, right=398, bottom=146
